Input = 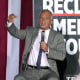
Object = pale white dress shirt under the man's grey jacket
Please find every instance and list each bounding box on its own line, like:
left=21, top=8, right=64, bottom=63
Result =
left=28, top=29, right=50, bottom=67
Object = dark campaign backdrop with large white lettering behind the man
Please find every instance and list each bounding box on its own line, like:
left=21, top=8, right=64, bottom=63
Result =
left=33, top=0, right=80, bottom=80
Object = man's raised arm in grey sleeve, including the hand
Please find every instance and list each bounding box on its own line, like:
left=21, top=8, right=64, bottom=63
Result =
left=6, top=14, right=26, bottom=40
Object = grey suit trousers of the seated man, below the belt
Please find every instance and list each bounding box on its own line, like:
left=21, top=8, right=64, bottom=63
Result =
left=14, top=69, right=59, bottom=80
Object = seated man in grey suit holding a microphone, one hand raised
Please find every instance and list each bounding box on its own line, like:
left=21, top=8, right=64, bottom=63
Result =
left=6, top=10, right=66, bottom=80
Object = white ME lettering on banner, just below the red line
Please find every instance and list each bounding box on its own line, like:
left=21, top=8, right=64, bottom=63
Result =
left=53, top=19, right=80, bottom=35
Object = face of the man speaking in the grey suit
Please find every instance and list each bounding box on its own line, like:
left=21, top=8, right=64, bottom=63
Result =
left=38, top=12, right=52, bottom=30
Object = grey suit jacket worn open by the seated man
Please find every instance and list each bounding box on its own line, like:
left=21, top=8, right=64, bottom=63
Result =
left=6, top=23, right=66, bottom=74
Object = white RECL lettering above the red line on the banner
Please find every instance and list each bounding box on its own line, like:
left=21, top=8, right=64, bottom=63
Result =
left=43, top=0, right=80, bottom=14
